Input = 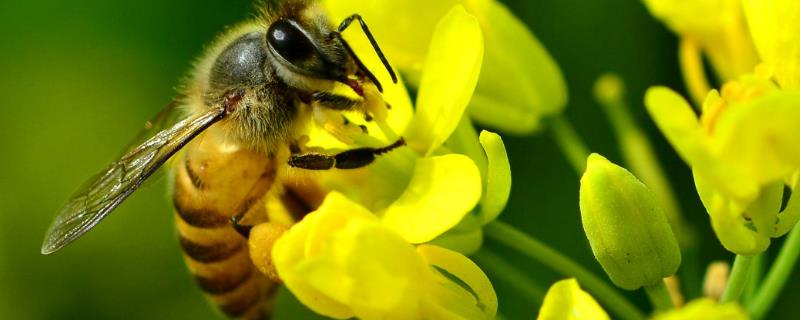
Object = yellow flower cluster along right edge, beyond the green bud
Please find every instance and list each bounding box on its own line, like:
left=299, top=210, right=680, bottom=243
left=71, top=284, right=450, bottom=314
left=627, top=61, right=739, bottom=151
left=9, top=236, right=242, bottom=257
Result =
left=645, top=1, right=800, bottom=255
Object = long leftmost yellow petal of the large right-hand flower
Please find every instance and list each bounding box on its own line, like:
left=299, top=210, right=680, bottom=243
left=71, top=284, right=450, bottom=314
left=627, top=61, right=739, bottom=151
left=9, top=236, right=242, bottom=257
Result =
left=645, top=87, right=759, bottom=203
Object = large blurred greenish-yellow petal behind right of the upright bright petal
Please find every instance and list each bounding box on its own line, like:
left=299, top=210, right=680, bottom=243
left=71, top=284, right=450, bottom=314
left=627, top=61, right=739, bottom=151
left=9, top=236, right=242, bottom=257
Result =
left=468, top=1, right=567, bottom=134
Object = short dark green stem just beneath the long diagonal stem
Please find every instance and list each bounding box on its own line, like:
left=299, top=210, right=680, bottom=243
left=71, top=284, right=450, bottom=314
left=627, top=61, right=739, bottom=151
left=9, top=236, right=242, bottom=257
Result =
left=470, top=247, right=545, bottom=305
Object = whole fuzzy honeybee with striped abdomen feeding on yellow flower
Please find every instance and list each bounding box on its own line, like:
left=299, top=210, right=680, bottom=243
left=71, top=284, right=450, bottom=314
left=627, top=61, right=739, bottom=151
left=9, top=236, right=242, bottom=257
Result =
left=41, top=0, right=404, bottom=318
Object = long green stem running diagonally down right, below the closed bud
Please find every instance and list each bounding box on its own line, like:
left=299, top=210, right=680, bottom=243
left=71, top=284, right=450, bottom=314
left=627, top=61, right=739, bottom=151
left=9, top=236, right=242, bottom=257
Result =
left=484, top=221, right=644, bottom=319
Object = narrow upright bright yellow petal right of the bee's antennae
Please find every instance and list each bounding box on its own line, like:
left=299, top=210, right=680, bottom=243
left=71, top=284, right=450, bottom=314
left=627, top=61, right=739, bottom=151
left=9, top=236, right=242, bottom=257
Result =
left=407, top=6, right=483, bottom=155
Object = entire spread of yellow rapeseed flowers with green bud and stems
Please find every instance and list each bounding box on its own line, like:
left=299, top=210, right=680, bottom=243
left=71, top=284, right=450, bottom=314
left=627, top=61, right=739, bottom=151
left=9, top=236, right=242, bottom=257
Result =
left=242, top=0, right=800, bottom=319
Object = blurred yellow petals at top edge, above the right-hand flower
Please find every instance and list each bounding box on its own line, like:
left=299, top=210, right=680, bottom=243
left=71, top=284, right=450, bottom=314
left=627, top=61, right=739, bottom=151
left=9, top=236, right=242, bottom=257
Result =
left=644, top=0, right=757, bottom=80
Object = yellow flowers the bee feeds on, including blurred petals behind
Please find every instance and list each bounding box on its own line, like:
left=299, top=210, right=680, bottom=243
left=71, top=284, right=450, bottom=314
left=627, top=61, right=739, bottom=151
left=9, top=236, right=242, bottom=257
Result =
left=251, top=1, right=566, bottom=319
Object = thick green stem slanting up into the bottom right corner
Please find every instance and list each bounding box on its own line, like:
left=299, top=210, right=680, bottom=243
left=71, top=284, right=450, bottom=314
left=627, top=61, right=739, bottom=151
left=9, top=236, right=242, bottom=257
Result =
left=747, top=226, right=800, bottom=319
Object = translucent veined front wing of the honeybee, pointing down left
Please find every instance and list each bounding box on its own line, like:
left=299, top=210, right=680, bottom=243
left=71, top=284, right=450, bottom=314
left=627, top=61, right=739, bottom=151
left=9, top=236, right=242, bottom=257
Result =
left=42, top=107, right=225, bottom=254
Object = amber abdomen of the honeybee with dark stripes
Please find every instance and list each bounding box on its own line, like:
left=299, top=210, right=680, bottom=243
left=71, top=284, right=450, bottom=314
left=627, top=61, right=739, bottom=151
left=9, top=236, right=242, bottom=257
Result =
left=173, top=135, right=277, bottom=319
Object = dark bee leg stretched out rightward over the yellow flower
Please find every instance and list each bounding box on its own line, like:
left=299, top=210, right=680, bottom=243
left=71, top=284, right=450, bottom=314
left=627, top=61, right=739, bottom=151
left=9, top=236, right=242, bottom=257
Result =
left=289, top=138, right=406, bottom=170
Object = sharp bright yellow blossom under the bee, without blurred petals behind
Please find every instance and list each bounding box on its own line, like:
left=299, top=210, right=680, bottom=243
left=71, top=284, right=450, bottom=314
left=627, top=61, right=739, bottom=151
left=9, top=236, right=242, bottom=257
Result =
left=258, top=6, right=510, bottom=319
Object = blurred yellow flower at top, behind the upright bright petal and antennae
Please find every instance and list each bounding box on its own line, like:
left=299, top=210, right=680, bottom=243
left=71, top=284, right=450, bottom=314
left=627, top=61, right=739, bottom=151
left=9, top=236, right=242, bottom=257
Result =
left=324, top=0, right=567, bottom=134
